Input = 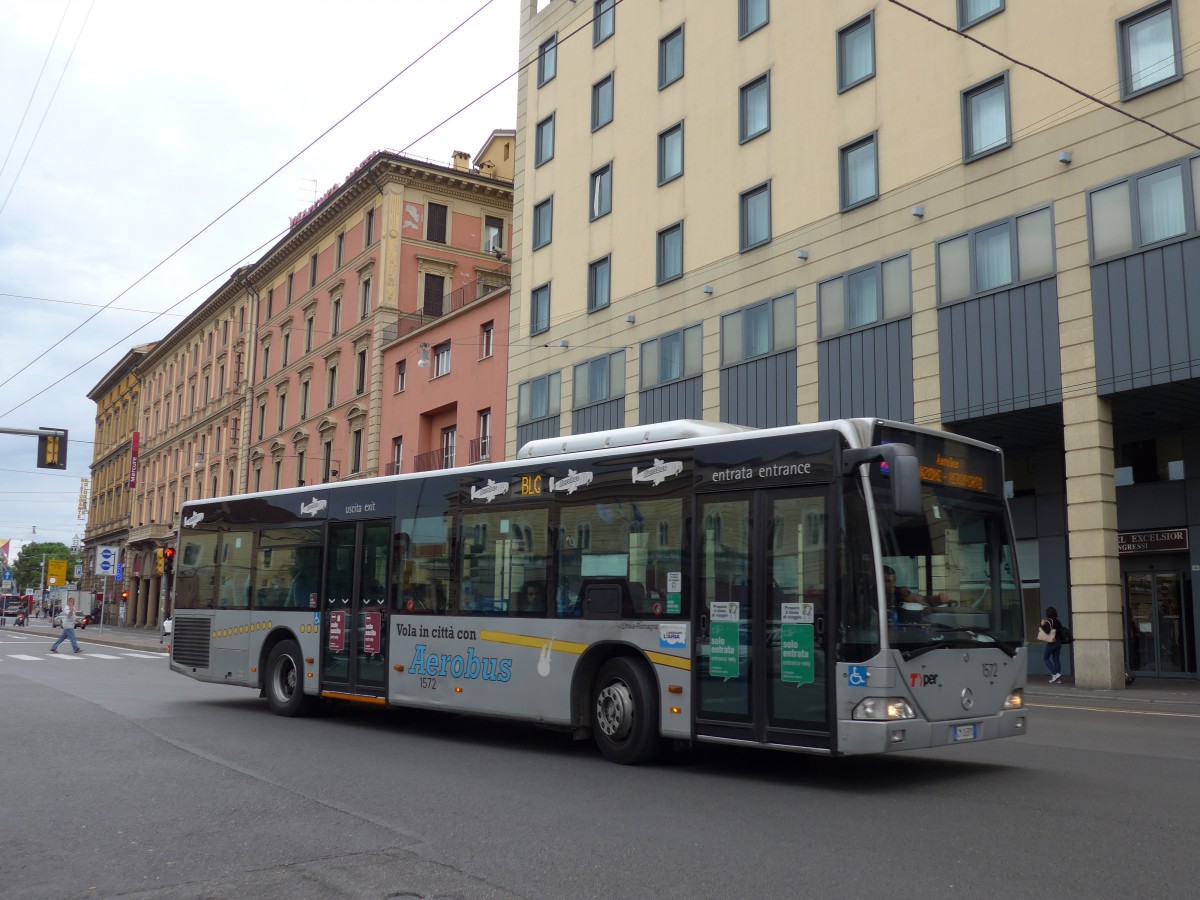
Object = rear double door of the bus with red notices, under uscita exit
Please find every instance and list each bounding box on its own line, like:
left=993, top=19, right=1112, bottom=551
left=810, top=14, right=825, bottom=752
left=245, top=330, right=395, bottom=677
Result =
left=320, top=521, right=392, bottom=697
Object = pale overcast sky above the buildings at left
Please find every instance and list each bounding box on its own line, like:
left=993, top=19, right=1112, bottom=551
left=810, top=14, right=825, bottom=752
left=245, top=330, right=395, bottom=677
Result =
left=0, top=0, right=520, bottom=566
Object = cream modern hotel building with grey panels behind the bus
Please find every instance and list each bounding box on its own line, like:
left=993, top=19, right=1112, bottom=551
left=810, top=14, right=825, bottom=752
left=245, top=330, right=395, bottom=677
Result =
left=508, top=0, right=1200, bottom=688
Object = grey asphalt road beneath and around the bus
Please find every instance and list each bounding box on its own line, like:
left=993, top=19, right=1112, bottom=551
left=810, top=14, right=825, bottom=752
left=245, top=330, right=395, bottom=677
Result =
left=0, top=630, right=1200, bottom=900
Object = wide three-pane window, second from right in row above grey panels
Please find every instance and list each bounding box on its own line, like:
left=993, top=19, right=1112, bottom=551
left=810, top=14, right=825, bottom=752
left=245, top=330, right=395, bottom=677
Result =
left=937, top=206, right=1055, bottom=304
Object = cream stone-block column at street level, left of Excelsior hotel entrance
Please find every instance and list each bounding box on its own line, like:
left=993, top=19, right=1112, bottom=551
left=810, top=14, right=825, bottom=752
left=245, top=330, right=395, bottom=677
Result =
left=1070, top=394, right=1124, bottom=690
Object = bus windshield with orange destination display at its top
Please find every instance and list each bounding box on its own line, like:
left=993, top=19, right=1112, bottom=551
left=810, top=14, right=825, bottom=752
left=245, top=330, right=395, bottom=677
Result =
left=872, top=433, right=1024, bottom=659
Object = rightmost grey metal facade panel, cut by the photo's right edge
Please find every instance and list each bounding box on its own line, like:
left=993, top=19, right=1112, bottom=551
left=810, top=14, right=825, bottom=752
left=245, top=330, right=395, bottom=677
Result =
left=1092, top=238, right=1200, bottom=395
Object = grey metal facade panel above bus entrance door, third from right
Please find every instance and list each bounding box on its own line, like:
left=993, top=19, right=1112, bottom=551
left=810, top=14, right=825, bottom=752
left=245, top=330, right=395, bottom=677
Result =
left=820, top=319, right=912, bottom=422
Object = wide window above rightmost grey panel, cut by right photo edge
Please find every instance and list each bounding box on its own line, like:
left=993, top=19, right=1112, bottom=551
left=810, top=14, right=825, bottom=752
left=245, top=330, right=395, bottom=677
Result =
left=1088, top=156, right=1200, bottom=259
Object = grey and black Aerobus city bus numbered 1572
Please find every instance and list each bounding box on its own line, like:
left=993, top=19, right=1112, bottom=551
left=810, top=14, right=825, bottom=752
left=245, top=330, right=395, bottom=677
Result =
left=170, top=419, right=1027, bottom=763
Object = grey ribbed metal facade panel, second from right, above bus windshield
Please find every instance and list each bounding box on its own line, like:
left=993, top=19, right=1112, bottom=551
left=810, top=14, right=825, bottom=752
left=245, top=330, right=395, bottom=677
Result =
left=937, top=278, right=1062, bottom=421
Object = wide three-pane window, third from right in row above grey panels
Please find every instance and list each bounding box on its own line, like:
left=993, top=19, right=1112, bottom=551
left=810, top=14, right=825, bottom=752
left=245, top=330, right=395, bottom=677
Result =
left=817, top=254, right=912, bottom=337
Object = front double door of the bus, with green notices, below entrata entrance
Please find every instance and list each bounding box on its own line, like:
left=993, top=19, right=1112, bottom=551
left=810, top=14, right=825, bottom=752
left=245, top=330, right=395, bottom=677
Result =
left=692, top=486, right=836, bottom=748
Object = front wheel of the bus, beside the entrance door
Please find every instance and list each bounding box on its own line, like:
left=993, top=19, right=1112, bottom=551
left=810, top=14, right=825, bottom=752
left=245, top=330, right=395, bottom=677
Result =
left=592, top=656, right=660, bottom=766
